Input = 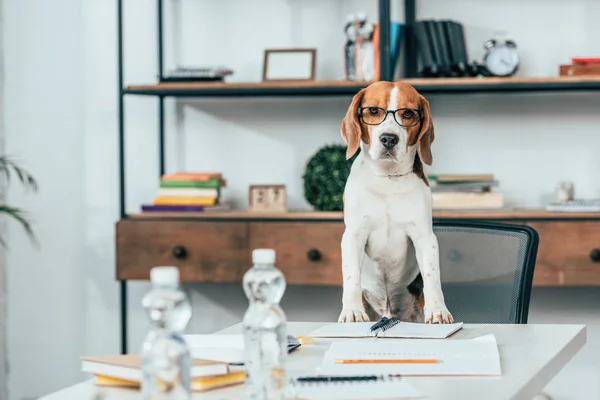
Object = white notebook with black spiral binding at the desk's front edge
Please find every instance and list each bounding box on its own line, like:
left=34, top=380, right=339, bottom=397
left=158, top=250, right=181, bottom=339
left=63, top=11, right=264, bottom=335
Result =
left=285, top=375, right=426, bottom=400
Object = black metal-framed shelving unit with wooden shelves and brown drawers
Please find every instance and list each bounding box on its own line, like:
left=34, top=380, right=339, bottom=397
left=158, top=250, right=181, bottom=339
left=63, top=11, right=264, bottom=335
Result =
left=116, top=0, right=600, bottom=353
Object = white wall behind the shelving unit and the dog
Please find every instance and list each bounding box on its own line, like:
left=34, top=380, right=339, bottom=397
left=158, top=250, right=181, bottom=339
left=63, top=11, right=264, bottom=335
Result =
left=3, top=0, right=600, bottom=400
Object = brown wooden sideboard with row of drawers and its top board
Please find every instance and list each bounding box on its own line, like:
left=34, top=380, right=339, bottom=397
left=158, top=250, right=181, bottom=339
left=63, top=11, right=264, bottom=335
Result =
left=116, top=211, right=600, bottom=286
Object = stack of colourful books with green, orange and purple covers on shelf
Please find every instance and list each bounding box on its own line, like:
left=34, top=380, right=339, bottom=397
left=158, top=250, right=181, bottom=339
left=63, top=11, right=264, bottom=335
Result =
left=142, top=172, right=225, bottom=212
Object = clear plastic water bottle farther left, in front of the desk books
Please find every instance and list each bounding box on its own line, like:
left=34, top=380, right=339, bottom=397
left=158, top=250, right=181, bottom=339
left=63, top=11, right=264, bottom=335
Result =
left=141, top=267, right=192, bottom=400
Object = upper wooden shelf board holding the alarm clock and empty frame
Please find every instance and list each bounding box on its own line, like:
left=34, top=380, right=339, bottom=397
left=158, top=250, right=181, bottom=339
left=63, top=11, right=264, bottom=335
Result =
left=123, top=76, right=600, bottom=97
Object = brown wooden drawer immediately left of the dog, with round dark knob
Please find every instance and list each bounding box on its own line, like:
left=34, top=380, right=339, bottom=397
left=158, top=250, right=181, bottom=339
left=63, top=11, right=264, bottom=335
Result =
left=250, top=222, right=344, bottom=286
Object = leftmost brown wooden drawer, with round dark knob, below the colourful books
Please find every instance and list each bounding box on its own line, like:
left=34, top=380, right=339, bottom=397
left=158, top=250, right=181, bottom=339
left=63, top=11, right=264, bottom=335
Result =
left=117, top=220, right=251, bottom=283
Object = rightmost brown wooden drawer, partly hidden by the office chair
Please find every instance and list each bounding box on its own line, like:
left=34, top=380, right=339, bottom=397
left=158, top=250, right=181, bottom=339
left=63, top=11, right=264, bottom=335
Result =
left=527, top=221, right=600, bottom=286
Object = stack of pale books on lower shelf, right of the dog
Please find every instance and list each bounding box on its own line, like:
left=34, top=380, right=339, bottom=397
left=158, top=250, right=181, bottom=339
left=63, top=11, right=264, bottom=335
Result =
left=428, top=174, right=504, bottom=210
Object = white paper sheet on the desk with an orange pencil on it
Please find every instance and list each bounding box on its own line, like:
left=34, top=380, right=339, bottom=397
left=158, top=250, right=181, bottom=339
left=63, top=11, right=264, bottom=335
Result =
left=317, top=335, right=501, bottom=376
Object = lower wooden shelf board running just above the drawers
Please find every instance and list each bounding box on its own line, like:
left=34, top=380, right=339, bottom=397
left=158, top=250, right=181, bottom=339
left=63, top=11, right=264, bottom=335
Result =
left=128, top=209, right=600, bottom=221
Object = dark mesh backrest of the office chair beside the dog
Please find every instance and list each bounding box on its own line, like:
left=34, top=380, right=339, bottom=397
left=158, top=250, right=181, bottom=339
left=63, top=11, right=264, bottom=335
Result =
left=434, top=220, right=539, bottom=324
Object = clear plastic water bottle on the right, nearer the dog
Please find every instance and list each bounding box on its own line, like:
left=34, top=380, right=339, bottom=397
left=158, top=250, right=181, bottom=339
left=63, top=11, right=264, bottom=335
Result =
left=243, top=249, right=287, bottom=400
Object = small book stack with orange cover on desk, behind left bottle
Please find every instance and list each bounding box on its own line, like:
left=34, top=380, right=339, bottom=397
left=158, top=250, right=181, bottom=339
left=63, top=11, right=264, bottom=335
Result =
left=81, top=354, right=246, bottom=392
